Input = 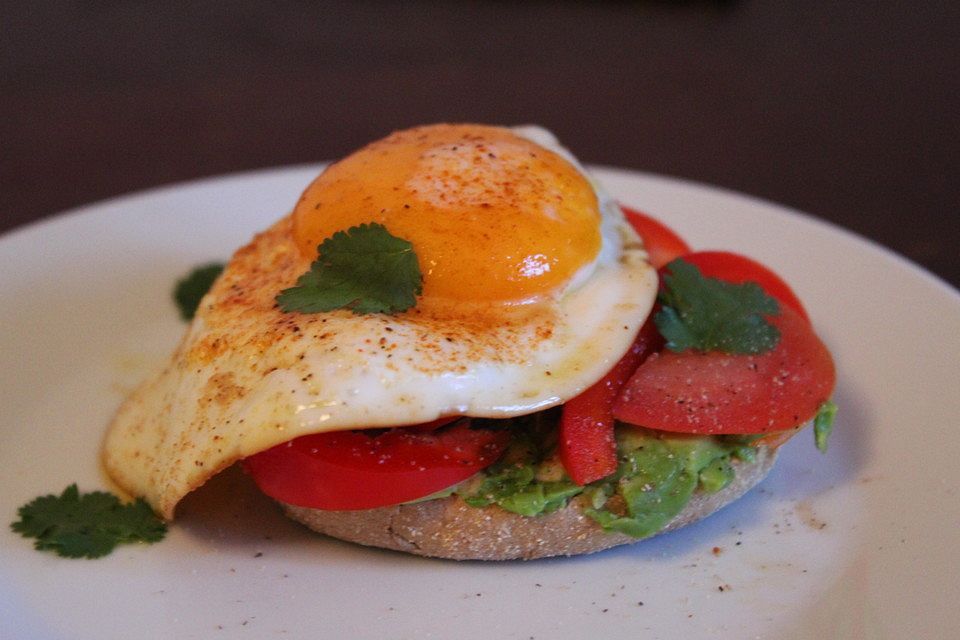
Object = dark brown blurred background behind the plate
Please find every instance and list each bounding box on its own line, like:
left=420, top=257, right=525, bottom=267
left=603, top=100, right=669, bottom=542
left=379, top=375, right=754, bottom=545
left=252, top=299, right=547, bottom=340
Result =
left=0, top=0, right=960, bottom=286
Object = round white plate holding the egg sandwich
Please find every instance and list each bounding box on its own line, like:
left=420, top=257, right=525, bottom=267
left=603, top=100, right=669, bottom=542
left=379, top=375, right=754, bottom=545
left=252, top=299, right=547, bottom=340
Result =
left=0, top=167, right=960, bottom=640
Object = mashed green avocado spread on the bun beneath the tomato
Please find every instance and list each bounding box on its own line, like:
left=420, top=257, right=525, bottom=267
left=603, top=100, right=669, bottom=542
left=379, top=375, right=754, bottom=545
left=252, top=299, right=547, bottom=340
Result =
left=455, top=424, right=756, bottom=538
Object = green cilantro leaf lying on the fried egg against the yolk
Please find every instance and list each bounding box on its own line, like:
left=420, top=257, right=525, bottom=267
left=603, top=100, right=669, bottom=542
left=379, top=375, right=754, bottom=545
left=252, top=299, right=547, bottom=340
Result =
left=277, top=223, right=423, bottom=314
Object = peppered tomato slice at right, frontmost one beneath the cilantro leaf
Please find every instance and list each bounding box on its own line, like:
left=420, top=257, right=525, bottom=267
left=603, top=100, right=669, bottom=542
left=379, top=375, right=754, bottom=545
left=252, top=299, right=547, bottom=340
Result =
left=613, top=305, right=836, bottom=435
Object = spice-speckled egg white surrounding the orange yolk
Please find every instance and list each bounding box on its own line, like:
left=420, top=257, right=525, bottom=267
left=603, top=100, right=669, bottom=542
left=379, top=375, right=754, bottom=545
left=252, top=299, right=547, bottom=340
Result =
left=104, top=127, right=657, bottom=518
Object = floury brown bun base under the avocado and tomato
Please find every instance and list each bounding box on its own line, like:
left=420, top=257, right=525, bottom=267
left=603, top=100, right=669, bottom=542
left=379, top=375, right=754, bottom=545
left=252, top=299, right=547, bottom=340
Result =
left=281, top=447, right=776, bottom=560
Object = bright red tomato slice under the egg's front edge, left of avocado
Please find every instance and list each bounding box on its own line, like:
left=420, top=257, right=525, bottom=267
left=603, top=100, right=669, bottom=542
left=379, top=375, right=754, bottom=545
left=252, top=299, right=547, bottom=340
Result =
left=244, top=419, right=510, bottom=511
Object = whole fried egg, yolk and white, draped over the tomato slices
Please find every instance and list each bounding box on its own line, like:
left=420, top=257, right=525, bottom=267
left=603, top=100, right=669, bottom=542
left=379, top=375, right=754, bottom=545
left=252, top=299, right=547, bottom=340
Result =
left=104, top=124, right=657, bottom=518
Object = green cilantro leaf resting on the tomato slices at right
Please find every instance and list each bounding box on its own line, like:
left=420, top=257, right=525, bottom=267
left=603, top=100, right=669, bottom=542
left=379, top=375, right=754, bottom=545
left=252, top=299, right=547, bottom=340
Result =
left=653, top=258, right=780, bottom=354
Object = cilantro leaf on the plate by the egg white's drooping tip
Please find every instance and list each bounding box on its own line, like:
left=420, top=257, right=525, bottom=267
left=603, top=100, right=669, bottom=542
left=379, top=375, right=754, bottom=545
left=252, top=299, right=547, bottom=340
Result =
left=10, top=484, right=167, bottom=558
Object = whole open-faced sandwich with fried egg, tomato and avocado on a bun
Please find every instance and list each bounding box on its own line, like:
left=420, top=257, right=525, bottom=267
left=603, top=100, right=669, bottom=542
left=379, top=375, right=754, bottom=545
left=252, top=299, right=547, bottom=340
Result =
left=104, top=124, right=835, bottom=560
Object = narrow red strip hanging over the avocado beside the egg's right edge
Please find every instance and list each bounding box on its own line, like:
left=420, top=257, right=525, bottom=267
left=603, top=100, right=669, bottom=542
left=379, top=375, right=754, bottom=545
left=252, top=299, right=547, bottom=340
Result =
left=558, top=320, right=663, bottom=486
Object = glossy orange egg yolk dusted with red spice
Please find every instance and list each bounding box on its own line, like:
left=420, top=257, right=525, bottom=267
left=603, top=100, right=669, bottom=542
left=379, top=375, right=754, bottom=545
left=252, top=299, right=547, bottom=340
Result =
left=293, top=125, right=600, bottom=303
